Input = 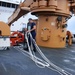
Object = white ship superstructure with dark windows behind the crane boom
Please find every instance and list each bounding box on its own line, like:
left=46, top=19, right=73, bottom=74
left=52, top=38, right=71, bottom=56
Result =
left=0, top=0, right=25, bottom=31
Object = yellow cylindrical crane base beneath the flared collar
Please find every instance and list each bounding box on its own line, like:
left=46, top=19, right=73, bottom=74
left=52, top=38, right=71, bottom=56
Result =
left=36, top=16, right=66, bottom=48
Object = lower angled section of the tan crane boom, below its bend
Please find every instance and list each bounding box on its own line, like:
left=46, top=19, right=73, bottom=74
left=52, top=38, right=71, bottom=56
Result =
left=8, top=7, right=30, bottom=26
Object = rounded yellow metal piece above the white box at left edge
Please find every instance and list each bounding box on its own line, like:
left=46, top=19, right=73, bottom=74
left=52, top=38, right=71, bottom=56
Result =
left=0, top=21, right=10, bottom=36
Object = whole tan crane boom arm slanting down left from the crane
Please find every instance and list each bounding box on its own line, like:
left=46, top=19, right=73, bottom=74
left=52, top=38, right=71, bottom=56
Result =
left=7, top=0, right=33, bottom=26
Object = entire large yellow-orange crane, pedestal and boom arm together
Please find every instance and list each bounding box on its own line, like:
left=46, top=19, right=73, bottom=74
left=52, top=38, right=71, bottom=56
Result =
left=7, top=0, right=75, bottom=48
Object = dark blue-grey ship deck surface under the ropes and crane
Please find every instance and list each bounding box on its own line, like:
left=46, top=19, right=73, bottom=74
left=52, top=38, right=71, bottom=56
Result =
left=0, top=44, right=75, bottom=75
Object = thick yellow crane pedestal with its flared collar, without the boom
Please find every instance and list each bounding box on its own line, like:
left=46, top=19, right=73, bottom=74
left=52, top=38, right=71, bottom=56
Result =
left=31, top=0, right=70, bottom=48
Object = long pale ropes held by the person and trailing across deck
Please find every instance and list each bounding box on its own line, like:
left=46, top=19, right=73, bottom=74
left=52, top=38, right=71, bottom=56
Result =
left=14, top=32, right=72, bottom=75
